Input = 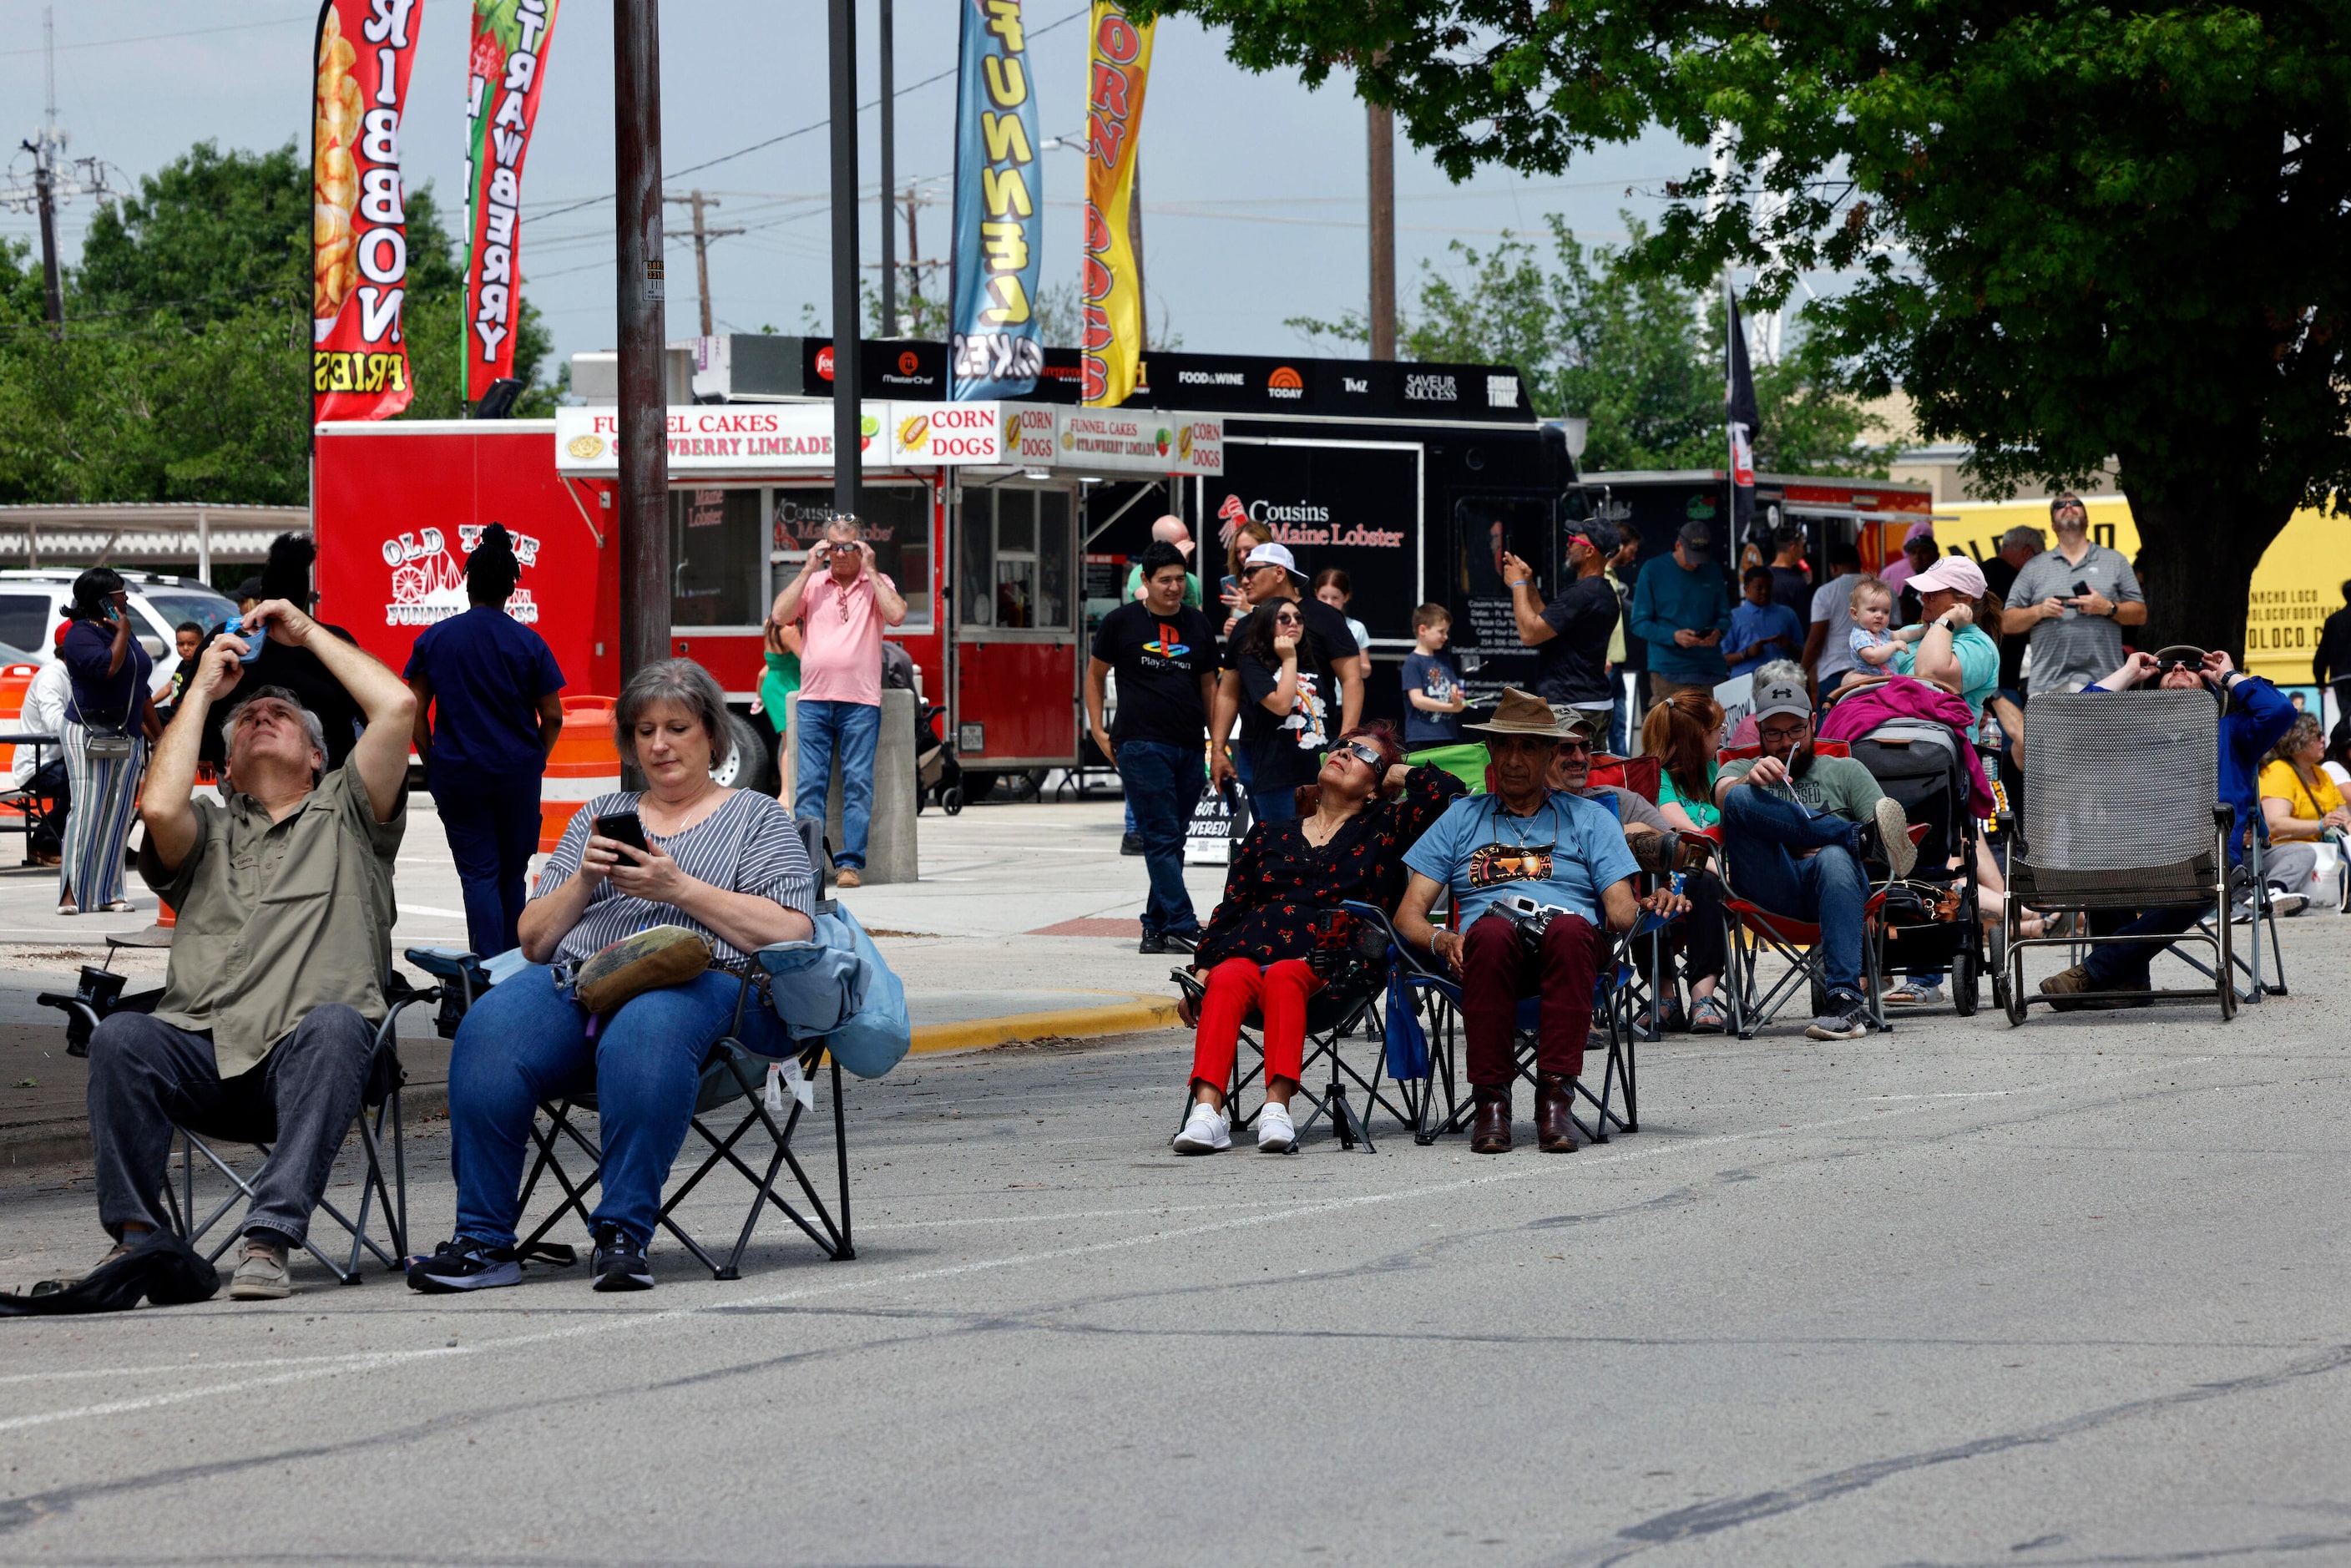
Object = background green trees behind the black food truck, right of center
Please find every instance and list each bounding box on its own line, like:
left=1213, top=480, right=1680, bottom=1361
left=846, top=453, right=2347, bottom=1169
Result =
left=1288, top=214, right=1883, bottom=475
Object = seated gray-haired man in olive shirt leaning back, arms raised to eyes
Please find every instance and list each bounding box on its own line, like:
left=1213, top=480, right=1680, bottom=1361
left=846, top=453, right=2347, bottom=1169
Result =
left=89, top=599, right=416, bottom=1300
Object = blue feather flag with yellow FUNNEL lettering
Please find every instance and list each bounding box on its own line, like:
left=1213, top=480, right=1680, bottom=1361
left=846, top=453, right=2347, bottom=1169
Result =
left=948, top=0, right=1044, bottom=402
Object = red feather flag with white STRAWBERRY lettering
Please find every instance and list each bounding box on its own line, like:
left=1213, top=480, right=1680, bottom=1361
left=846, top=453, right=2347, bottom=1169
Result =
left=466, top=0, right=562, bottom=404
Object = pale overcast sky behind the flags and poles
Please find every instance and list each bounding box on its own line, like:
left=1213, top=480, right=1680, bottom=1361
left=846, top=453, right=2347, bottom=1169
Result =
left=0, top=0, right=1695, bottom=376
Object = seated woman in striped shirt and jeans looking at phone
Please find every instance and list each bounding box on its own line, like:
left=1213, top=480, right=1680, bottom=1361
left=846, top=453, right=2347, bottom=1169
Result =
left=409, top=658, right=816, bottom=1293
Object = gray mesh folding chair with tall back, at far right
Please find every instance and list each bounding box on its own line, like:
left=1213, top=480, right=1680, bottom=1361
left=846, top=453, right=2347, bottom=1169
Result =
left=1994, top=689, right=2238, bottom=1025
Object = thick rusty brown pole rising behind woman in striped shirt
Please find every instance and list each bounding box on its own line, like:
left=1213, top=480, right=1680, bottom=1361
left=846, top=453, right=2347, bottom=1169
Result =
left=611, top=0, right=670, bottom=701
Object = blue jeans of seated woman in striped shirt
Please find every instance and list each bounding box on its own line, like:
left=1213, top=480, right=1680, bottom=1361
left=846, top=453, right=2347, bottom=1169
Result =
left=449, top=964, right=792, bottom=1246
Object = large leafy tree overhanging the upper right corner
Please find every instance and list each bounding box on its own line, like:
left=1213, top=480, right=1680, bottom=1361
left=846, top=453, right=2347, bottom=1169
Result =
left=1156, top=0, right=2351, bottom=649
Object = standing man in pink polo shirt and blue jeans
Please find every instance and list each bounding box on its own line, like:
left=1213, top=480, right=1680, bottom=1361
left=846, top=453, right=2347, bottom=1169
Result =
left=771, top=517, right=905, bottom=888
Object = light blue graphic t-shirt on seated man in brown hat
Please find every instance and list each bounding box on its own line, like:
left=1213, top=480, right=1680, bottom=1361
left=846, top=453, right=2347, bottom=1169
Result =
left=1403, top=790, right=1641, bottom=931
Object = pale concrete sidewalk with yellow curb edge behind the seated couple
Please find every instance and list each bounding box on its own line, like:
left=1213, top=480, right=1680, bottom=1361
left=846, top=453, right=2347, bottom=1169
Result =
left=0, top=795, right=1222, bottom=1166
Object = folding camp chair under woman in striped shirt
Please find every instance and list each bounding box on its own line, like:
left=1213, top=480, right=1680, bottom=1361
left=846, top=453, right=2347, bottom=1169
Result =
left=409, top=818, right=856, bottom=1279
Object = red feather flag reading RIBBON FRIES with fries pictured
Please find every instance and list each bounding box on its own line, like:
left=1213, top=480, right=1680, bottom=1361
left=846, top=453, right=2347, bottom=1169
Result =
left=311, top=0, right=423, bottom=421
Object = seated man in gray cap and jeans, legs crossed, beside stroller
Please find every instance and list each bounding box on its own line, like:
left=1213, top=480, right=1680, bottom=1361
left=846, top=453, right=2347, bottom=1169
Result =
left=1714, top=682, right=1919, bottom=1039
